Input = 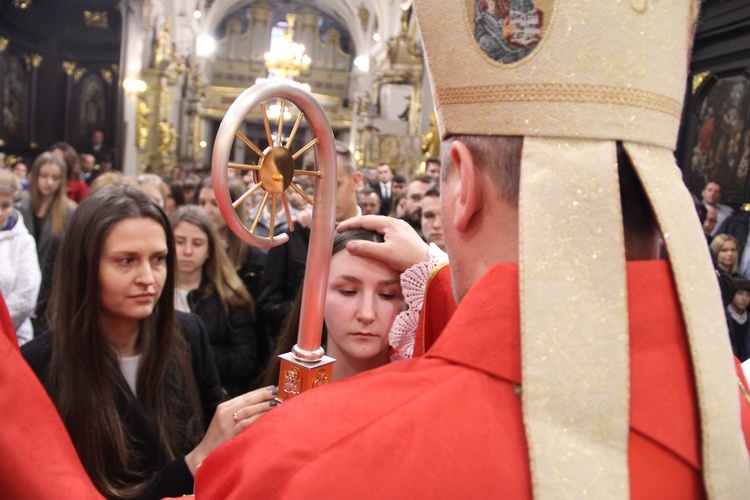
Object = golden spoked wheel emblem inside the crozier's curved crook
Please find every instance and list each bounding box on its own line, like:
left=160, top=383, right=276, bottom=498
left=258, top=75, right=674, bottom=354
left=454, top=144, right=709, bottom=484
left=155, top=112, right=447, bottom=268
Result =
left=227, top=99, right=323, bottom=241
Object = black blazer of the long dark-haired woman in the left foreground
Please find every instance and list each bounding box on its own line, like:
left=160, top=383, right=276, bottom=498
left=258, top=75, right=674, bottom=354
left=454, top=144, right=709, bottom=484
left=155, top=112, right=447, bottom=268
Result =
left=21, top=312, right=225, bottom=499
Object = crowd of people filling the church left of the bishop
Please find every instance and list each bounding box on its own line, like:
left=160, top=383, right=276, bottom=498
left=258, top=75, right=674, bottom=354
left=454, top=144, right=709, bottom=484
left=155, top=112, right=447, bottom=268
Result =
left=0, top=136, right=444, bottom=498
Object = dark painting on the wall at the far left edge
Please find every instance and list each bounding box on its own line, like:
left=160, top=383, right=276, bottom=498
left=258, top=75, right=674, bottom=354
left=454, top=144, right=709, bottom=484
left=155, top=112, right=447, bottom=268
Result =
left=2, top=54, right=28, bottom=142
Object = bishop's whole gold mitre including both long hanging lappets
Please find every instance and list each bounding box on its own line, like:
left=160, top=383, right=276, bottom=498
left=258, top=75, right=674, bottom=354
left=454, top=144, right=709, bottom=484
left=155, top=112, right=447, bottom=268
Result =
left=415, top=0, right=750, bottom=499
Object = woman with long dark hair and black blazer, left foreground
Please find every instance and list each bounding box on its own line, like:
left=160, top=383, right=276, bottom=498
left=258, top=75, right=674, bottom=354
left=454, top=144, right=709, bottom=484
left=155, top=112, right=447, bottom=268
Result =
left=22, top=186, right=274, bottom=498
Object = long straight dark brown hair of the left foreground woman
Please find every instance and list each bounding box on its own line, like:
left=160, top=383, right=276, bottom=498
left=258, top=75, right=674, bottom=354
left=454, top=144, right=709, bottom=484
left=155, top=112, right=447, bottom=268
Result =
left=45, top=186, right=203, bottom=498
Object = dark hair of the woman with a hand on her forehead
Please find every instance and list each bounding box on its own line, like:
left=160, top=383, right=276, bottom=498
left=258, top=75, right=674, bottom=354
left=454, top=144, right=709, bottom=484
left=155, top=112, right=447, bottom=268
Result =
left=258, top=229, right=383, bottom=387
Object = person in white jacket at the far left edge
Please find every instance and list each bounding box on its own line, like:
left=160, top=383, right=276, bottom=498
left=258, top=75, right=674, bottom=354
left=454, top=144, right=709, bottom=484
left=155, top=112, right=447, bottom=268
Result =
left=0, top=170, right=42, bottom=345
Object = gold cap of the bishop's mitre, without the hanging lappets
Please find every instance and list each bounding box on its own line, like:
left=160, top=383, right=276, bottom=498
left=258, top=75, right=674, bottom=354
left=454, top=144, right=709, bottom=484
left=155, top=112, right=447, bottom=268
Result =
left=424, top=0, right=697, bottom=148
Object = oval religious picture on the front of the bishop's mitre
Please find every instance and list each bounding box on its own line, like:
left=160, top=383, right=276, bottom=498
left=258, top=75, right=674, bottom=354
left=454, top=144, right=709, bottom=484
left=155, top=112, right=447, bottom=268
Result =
left=473, top=0, right=553, bottom=64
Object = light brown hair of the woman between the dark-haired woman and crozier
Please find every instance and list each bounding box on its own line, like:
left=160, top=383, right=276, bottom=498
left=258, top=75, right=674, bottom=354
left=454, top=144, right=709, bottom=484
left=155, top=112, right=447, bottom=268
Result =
left=169, top=205, right=253, bottom=310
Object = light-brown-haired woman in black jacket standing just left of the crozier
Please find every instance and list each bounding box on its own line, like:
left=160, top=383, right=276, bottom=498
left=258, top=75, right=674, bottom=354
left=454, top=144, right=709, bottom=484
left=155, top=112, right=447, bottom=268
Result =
left=170, top=205, right=266, bottom=396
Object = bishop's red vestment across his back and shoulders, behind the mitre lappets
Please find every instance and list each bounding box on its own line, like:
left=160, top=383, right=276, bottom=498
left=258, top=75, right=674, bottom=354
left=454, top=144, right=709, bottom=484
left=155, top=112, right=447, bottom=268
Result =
left=196, top=261, right=750, bottom=499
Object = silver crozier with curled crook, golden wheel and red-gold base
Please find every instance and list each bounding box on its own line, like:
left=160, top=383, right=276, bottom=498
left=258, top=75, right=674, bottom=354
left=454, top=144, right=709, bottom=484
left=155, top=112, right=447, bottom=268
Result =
left=211, top=81, right=336, bottom=401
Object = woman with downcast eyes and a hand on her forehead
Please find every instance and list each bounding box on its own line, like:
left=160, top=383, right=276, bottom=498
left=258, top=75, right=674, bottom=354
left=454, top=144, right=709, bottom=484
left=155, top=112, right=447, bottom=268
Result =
left=264, top=229, right=404, bottom=381
